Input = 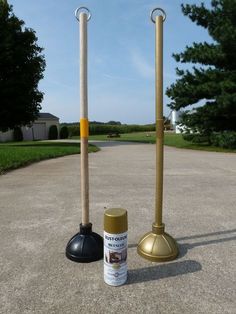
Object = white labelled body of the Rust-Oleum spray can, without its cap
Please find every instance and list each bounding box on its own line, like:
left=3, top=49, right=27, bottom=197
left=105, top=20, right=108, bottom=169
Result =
left=104, top=231, right=128, bottom=286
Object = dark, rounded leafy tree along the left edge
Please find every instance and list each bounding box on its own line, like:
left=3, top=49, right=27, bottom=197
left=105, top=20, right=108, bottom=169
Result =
left=0, top=0, right=45, bottom=131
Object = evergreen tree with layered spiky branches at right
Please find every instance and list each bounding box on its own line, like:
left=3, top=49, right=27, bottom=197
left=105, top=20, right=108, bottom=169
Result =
left=166, top=0, right=236, bottom=136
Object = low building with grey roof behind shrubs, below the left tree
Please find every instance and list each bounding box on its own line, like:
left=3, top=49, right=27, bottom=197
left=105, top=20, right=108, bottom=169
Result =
left=0, top=112, right=59, bottom=142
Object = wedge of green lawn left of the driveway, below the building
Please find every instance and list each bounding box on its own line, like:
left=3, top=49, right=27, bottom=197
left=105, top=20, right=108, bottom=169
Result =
left=0, top=141, right=99, bottom=174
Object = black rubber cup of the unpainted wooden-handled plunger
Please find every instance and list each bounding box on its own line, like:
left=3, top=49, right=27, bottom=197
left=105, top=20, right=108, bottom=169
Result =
left=66, top=223, right=103, bottom=263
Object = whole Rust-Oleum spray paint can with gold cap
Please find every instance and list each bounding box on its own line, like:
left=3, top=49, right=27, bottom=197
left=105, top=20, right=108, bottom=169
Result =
left=104, top=208, right=128, bottom=286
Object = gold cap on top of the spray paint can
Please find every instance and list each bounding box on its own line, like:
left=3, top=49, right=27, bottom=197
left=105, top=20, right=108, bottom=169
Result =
left=104, top=208, right=128, bottom=234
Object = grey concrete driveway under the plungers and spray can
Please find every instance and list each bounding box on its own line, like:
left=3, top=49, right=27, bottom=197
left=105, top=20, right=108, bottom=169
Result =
left=0, top=142, right=236, bottom=314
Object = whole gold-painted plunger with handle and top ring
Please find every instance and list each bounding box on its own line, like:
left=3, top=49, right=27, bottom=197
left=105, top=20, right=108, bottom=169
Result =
left=137, top=8, right=178, bottom=262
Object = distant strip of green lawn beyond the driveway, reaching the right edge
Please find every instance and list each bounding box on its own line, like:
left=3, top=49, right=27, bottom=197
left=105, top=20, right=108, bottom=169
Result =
left=73, top=132, right=236, bottom=153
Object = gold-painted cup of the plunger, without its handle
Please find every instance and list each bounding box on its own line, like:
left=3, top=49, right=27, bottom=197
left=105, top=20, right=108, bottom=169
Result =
left=137, top=224, right=179, bottom=262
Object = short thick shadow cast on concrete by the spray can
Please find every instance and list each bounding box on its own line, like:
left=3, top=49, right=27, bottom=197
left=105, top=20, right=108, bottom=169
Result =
left=127, top=260, right=202, bottom=285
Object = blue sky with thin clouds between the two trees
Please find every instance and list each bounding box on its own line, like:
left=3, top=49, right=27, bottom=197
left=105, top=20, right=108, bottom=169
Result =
left=9, top=0, right=212, bottom=124
